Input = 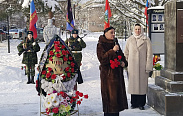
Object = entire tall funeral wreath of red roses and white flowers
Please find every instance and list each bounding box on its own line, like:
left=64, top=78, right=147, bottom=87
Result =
left=36, top=41, right=88, bottom=116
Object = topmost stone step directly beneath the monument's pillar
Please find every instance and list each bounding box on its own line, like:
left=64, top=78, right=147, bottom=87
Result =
left=160, top=69, right=183, bottom=81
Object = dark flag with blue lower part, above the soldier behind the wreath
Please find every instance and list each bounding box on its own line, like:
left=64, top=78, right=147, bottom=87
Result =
left=66, top=0, right=74, bottom=31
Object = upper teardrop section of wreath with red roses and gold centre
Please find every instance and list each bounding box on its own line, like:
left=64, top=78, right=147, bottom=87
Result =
left=41, top=41, right=77, bottom=83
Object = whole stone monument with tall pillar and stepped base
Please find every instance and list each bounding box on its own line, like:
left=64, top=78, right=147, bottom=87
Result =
left=147, top=0, right=183, bottom=116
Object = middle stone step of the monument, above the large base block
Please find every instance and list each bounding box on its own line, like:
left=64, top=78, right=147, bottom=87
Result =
left=155, top=76, right=183, bottom=93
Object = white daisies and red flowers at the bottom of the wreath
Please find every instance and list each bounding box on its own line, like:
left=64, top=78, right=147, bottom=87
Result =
left=43, top=91, right=88, bottom=116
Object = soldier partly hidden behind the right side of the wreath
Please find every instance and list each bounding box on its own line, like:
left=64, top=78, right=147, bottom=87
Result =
left=65, top=29, right=86, bottom=67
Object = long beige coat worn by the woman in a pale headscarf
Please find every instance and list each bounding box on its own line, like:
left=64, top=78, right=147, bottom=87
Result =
left=124, top=35, right=153, bottom=95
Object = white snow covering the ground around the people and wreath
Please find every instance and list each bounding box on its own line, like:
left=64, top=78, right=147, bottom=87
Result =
left=0, top=32, right=160, bottom=116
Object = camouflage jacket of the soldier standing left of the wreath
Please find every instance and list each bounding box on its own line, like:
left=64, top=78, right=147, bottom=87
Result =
left=17, top=38, right=40, bottom=64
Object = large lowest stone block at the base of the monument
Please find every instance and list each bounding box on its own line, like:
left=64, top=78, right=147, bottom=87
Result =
left=147, top=85, right=183, bottom=116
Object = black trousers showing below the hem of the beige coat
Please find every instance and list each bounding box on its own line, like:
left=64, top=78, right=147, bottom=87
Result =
left=131, top=94, right=146, bottom=107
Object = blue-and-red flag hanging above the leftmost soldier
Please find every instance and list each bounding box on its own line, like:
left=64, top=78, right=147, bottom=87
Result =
left=29, top=0, right=38, bottom=39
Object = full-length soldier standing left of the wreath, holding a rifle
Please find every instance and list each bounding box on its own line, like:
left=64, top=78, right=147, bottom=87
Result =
left=17, top=31, right=40, bottom=84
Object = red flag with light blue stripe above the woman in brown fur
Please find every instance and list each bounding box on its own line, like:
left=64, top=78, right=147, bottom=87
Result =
left=104, top=0, right=111, bottom=30
